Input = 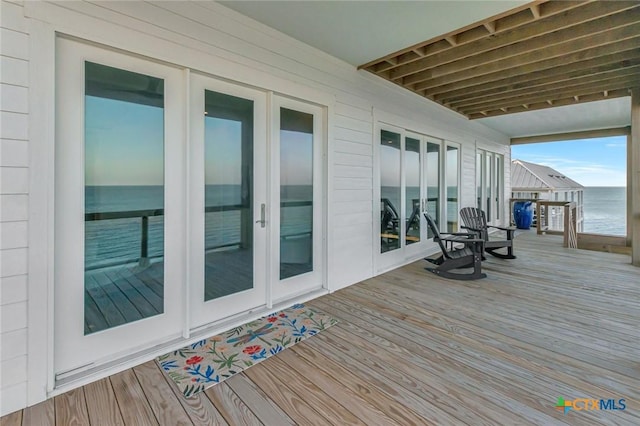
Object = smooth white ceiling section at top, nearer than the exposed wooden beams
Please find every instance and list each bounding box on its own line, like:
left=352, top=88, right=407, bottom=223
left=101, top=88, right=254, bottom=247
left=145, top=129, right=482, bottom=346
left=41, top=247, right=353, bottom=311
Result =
left=220, top=0, right=527, bottom=66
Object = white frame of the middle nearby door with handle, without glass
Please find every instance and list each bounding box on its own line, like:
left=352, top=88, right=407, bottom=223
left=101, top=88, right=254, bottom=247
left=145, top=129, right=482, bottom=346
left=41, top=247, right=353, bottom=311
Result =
left=188, top=73, right=272, bottom=329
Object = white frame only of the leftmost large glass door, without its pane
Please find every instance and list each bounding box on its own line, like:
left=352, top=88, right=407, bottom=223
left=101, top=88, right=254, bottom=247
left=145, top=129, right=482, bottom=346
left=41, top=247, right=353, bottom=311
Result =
left=54, top=38, right=185, bottom=378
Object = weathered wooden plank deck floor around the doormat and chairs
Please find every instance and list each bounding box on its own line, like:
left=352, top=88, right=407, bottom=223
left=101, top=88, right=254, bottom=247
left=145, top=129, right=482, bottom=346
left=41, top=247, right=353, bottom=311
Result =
left=0, top=231, right=640, bottom=426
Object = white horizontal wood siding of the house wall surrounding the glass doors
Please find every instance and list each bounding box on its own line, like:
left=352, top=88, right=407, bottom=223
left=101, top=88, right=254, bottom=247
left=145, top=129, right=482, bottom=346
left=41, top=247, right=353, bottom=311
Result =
left=0, top=0, right=509, bottom=415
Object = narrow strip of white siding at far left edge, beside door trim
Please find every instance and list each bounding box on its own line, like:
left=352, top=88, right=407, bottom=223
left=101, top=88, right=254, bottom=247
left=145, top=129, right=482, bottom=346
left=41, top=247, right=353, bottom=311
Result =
left=0, top=1, right=29, bottom=415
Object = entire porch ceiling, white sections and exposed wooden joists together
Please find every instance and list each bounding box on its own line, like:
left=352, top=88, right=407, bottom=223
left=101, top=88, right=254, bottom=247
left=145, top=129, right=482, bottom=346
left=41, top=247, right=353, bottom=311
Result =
left=222, top=0, right=640, bottom=137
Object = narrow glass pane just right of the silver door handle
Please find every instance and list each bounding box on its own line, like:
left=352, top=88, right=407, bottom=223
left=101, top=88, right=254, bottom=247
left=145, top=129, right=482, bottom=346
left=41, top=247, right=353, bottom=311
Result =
left=280, top=108, right=313, bottom=279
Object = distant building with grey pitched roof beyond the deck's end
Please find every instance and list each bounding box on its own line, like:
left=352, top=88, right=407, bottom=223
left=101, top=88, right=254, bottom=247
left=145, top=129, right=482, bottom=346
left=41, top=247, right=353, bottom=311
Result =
left=511, top=160, right=584, bottom=231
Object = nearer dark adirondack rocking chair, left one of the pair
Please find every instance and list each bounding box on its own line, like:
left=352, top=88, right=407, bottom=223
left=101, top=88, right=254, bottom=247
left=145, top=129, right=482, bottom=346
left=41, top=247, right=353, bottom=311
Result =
left=424, top=213, right=487, bottom=280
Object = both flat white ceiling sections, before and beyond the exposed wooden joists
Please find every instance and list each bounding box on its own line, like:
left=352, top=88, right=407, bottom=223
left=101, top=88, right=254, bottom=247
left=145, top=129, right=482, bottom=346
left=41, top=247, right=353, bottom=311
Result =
left=220, top=0, right=631, bottom=137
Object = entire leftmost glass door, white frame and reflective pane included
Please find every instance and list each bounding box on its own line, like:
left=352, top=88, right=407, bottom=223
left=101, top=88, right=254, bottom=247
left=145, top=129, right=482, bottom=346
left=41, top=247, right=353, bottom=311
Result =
left=54, top=39, right=185, bottom=380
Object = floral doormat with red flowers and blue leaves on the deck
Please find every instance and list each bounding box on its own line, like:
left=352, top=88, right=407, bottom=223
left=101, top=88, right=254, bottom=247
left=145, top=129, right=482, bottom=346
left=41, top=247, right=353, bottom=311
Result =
left=156, top=304, right=338, bottom=397
